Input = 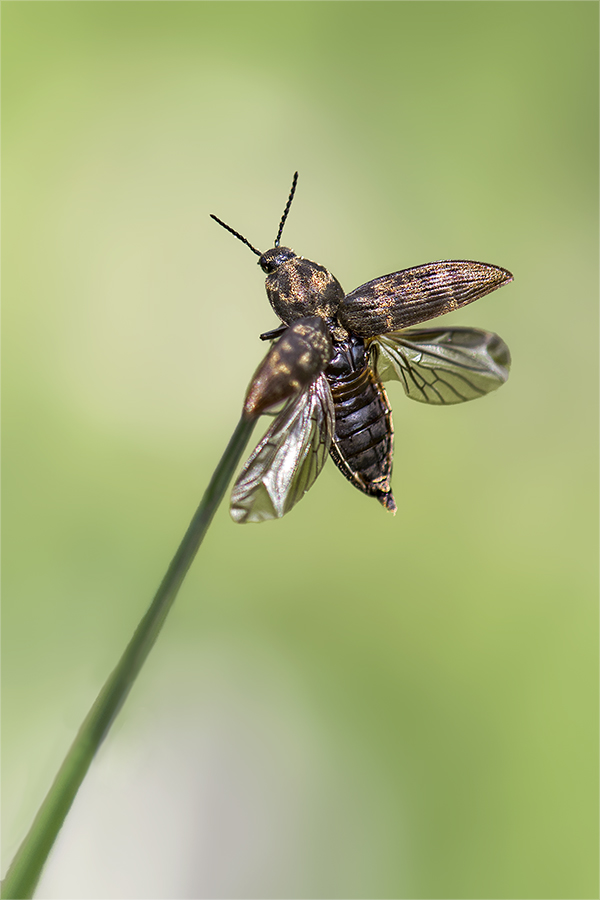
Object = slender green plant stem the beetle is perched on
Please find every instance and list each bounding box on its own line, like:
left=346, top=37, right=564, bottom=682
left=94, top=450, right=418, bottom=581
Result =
left=2, top=416, right=255, bottom=900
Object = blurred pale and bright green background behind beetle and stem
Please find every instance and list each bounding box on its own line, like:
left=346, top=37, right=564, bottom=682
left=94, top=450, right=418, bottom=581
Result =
left=2, top=2, right=598, bottom=898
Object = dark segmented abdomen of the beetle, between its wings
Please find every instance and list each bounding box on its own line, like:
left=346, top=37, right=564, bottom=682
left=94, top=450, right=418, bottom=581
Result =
left=325, top=336, right=396, bottom=512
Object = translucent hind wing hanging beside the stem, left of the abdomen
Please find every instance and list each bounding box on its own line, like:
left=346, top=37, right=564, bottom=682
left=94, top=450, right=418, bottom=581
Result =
left=230, top=375, right=334, bottom=524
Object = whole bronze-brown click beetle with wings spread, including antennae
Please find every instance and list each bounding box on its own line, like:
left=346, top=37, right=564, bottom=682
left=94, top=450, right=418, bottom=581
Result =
left=212, top=172, right=513, bottom=523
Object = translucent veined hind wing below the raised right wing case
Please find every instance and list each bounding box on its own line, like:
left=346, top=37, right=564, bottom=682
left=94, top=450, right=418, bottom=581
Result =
left=371, top=328, right=510, bottom=404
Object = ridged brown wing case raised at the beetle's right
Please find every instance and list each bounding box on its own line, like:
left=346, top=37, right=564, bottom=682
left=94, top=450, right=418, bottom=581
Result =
left=337, top=260, right=513, bottom=337
